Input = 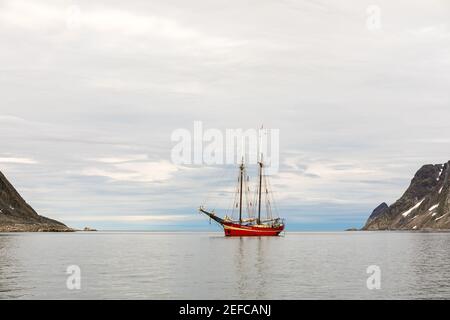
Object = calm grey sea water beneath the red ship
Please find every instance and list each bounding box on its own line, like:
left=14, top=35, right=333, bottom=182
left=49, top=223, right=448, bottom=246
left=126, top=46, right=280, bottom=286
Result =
left=0, top=232, right=450, bottom=299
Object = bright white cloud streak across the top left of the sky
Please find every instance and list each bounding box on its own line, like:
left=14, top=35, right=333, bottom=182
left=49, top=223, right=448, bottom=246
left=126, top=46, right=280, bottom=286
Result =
left=0, top=0, right=243, bottom=48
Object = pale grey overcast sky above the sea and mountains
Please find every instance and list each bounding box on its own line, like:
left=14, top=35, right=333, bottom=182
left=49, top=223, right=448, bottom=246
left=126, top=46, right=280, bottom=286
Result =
left=0, top=0, right=450, bottom=230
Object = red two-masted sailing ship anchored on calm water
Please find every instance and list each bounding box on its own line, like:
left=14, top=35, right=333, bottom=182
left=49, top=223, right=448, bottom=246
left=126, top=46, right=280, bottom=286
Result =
left=199, top=156, right=285, bottom=237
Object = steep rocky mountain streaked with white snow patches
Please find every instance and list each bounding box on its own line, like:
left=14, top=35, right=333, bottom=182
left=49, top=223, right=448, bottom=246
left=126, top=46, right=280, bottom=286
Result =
left=363, top=161, right=450, bottom=230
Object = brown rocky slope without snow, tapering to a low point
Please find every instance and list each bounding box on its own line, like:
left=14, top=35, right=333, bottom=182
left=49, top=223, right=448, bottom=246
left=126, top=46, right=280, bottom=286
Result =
left=0, top=172, right=72, bottom=232
